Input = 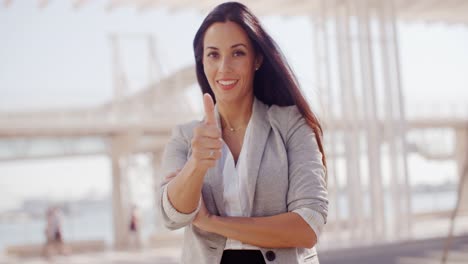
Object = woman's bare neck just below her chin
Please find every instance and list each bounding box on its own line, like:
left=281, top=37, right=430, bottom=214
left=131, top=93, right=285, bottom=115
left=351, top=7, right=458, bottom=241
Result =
left=217, top=95, right=253, bottom=129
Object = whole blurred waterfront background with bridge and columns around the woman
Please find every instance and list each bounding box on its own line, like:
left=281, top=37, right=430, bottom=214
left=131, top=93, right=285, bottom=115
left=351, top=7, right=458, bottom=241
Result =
left=0, top=0, right=468, bottom=264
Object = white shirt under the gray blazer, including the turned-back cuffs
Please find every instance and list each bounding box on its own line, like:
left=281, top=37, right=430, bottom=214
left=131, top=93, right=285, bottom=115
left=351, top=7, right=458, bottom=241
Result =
left=163, top=117, right=325, bottom=249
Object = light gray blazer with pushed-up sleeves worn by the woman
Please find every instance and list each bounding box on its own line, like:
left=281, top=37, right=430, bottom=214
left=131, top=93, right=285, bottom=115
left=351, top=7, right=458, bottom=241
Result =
left=158, top=99, right=328, bottom=264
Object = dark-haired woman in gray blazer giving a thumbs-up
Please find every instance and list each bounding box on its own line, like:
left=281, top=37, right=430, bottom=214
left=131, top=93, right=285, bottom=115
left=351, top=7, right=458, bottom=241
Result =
left=160, top=2, right=328, bottom=264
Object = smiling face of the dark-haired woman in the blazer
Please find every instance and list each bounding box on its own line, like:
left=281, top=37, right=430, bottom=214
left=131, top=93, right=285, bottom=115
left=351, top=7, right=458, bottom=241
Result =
left=203, top=21, right=262, bottom=103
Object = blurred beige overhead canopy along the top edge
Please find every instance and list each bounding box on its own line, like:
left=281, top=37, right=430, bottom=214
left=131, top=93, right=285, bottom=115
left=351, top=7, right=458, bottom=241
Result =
left=103, top=0, right=468, bottom=24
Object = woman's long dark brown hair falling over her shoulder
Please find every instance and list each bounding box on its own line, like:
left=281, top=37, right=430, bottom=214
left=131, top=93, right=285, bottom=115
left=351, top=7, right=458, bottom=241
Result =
left=193, top=2, right=327, bottom=167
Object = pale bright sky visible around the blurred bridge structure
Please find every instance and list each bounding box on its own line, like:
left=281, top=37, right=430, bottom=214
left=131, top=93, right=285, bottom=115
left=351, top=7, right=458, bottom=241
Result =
left=0, top=1, right=468, bottom=210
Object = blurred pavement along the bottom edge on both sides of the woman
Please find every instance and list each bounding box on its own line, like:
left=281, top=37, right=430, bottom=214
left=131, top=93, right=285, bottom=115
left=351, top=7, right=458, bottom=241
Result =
left=0, top=234, right=468, bottom=264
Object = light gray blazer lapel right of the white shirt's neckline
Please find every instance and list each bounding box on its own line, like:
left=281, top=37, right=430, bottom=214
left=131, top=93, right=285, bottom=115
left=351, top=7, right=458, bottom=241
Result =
left=244, top=98, right=271, bottom=216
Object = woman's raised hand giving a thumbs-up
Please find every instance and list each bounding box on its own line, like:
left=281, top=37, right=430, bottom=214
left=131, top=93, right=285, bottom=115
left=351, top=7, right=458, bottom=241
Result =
left=191, top=93, right=223, bottom=170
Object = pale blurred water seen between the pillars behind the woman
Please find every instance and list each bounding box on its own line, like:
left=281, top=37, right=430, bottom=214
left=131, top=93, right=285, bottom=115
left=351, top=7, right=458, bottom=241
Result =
left=0, top=191, right=456, bottom=251
